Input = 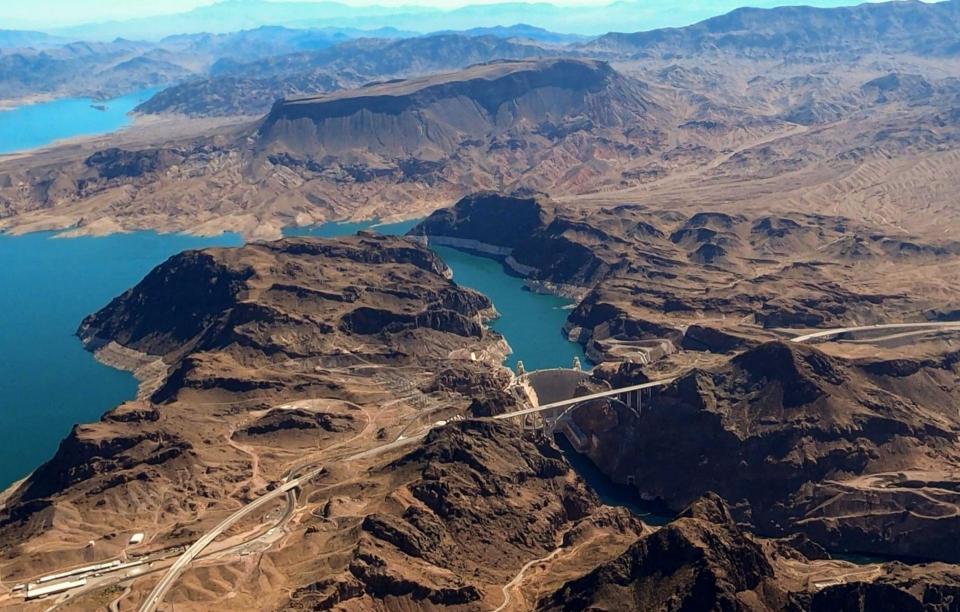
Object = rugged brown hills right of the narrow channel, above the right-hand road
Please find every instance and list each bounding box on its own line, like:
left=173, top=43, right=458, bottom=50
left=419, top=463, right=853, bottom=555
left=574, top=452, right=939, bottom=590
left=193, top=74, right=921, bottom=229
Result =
left=411, top=192, right=960, bottom=362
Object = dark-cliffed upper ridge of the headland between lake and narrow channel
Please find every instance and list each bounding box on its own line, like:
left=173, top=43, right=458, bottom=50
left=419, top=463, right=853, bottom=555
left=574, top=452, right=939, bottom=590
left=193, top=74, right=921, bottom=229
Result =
left=78, top=234, right=491, bottom=378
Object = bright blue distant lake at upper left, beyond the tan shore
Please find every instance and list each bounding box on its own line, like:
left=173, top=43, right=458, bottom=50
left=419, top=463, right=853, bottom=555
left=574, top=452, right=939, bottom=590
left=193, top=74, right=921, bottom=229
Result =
left=0, top=89, right=158, bottom=153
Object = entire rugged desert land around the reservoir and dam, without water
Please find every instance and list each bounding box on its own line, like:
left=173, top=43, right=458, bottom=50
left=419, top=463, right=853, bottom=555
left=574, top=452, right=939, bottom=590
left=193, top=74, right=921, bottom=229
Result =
left=0, top=0, right=960, bottom=612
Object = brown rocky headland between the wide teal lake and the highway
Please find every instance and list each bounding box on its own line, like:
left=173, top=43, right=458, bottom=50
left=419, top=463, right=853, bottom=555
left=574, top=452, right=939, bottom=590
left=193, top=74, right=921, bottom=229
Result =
left=0, top=234, right=506, bottom=575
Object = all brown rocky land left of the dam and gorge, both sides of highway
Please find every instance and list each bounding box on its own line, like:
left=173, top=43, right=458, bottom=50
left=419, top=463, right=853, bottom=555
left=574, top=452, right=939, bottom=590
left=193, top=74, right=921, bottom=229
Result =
left=0, top=233, right=643, bottom=610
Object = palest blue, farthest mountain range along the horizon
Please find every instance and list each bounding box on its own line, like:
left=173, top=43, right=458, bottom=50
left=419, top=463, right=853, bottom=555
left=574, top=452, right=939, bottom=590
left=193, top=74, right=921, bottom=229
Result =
left=52, top=0, right=884, bottom=40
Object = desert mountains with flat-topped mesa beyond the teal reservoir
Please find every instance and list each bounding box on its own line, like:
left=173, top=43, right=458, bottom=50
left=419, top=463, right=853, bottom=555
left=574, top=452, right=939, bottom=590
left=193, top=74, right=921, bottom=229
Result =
left=0, top=0, right=960, bottom=241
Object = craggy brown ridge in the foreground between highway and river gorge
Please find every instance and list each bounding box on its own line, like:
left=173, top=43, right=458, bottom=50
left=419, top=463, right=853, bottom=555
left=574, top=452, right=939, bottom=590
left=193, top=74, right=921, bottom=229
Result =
left=284, top=421, right=641, bottom=610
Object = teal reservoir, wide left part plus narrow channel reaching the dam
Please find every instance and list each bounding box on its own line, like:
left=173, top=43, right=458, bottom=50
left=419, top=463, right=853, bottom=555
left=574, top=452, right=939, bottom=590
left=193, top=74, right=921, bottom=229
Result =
left=0, top=221, right=586, bottom=489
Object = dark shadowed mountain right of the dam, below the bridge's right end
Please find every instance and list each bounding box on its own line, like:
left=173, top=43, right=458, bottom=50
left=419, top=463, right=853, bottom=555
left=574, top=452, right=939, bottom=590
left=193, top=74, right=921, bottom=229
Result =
left=574, top=342, right=960, bottom=561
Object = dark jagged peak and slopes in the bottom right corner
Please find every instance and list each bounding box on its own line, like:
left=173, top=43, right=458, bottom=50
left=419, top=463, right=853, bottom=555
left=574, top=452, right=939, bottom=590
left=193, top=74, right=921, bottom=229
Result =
left=537, top=493, right=960, bottom=612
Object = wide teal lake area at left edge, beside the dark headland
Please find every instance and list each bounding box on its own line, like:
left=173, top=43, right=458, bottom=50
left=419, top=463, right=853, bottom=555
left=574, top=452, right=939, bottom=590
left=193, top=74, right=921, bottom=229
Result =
left=0, top=232, right=241, bottom=488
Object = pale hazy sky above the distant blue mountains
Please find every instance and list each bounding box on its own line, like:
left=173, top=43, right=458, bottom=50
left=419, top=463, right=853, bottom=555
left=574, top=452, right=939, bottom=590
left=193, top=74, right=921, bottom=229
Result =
left=0, top=0, right=900, bottom=29
